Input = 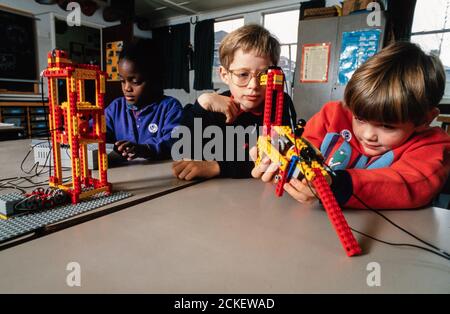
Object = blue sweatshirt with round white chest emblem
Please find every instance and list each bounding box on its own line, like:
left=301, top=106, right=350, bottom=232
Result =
left=105, top=96, right=183, bottom=159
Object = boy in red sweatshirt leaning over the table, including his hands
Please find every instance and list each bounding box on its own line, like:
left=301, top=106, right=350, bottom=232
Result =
left=252, top=42, right=450, bottom=209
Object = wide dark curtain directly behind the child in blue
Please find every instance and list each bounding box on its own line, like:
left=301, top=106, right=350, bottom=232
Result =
left=152, top=23, right=190, bottom=93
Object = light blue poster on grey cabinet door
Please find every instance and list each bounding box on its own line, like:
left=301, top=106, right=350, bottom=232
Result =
left=338, top=29, right=381, bottom=85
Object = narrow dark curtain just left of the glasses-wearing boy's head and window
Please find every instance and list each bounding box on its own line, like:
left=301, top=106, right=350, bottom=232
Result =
left=194, top=20, right=214, bottom=90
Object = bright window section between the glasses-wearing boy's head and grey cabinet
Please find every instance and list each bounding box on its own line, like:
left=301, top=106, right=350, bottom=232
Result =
left=264, top=10, right=300, bottom=86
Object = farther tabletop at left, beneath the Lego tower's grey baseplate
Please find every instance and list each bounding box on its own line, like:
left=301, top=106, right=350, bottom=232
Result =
left=0, top=140, right=197, bottom=245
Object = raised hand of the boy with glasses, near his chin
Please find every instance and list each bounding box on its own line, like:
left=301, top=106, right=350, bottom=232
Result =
left=197, top=93, right=241, bottom=123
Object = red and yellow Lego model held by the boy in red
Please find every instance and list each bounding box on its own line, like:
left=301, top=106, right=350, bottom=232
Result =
left=256, top=67, right=361, bottom=256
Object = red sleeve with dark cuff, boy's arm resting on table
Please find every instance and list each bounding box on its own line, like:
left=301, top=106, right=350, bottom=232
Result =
left=332, top=142, right=450, bottom=209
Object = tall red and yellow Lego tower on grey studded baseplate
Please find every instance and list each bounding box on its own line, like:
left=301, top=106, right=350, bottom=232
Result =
left=0, top=50, right=131, bottom=244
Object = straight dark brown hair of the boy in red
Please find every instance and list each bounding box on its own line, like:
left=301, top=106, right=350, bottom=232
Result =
left=344, top=42, right=445, bottom=125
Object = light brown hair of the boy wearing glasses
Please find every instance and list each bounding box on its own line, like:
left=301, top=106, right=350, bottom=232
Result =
left=219, top=24, right=281, bottom=70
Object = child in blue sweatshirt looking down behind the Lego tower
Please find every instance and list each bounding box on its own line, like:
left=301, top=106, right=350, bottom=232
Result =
left=105, top=39, right=183, bottom=160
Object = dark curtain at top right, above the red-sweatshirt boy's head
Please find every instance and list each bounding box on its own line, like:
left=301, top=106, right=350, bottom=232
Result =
left=384, top=0, right=416, bottom=46
